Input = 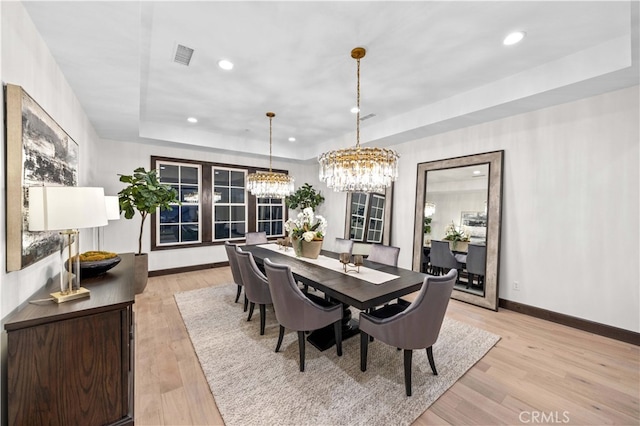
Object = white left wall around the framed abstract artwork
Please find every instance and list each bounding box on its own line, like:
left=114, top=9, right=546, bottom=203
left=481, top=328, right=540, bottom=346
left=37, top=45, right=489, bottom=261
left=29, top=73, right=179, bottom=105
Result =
left=0, top=2, right=99, bottom=318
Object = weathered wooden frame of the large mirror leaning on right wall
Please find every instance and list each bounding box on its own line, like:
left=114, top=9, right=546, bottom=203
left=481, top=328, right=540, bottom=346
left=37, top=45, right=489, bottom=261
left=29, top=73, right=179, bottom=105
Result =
left=413, top=150, right=504, bottom=311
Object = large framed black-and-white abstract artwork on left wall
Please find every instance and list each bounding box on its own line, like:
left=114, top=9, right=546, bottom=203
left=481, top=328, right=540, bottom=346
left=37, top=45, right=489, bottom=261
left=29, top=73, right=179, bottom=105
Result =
left=5, top=84, right=78, bottom=272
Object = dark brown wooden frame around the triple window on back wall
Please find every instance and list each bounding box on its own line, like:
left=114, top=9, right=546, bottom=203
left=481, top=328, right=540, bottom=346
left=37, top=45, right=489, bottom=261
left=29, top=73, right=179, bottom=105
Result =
left=150, top=155, right=289, bottom=251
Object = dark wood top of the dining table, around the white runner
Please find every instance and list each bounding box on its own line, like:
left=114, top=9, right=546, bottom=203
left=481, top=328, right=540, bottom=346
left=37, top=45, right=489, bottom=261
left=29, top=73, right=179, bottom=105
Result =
left=240, top=245, right=425, bottom=310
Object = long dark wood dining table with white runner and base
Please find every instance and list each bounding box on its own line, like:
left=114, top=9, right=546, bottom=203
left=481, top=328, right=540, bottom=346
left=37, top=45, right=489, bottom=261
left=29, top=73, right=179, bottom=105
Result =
left=240, top=243, right=426, bottom=351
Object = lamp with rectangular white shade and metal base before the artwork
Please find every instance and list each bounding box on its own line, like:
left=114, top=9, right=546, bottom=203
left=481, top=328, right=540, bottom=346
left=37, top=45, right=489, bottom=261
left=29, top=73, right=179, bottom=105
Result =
left=29, top=186, right=107, bottom=303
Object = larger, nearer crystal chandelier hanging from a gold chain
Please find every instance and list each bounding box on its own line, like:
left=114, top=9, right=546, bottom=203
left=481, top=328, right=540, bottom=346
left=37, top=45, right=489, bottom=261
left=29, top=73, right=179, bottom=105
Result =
left=318, top=47, right=399, bottom=192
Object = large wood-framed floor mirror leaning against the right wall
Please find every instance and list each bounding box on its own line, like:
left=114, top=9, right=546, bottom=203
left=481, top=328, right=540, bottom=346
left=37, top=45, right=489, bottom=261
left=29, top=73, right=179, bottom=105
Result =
left=413, top=151, right=504, bottom=311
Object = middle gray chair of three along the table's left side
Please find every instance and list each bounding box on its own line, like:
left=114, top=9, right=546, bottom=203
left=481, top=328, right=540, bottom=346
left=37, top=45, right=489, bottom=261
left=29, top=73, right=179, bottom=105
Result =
left=236, top=247, right=273, bottom=336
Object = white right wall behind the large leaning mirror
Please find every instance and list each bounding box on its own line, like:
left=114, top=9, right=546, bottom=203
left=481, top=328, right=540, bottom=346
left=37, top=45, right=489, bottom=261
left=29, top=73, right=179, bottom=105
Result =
left=392, top=86, right=640, bottom=332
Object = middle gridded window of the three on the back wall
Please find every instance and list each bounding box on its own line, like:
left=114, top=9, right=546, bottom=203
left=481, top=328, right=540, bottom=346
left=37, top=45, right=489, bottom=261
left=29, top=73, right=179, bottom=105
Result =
left=213, top=167, right=247, bottom=241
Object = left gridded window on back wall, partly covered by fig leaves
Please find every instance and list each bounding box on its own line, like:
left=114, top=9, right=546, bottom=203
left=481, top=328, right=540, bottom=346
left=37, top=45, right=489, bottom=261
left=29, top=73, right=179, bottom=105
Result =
left=157, top=161, right=201, bottom=245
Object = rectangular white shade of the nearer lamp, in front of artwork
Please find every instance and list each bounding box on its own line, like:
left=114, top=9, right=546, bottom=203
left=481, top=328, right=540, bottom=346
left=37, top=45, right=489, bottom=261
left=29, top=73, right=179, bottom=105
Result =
left=29, top=186, right=107, bottom=231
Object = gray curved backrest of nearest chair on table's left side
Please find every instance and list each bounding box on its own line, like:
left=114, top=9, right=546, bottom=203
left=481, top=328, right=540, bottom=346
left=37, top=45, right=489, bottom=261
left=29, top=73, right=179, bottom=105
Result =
left=264, top=258, right=342, bottom=331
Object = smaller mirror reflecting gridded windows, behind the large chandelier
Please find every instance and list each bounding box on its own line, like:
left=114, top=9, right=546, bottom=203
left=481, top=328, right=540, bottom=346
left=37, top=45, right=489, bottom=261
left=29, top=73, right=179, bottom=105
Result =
left=344, top=186, right=393, bottom=254
